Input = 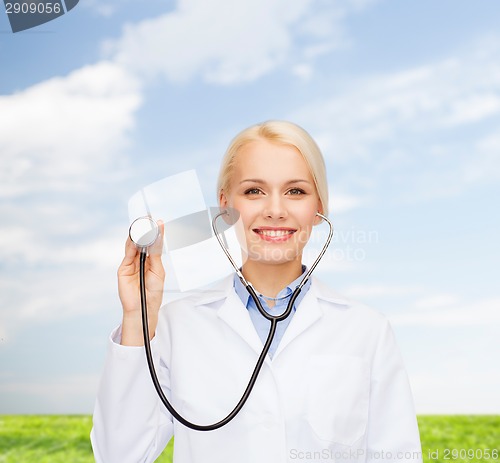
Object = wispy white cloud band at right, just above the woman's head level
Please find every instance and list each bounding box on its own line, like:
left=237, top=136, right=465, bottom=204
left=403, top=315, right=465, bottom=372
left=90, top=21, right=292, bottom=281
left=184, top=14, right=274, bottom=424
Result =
left=297, top=56, right=500, bottom=160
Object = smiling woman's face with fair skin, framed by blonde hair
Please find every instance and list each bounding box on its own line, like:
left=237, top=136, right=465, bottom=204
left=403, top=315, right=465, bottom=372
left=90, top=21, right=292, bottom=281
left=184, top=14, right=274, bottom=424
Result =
left=220, top=140, right=321, bottom=264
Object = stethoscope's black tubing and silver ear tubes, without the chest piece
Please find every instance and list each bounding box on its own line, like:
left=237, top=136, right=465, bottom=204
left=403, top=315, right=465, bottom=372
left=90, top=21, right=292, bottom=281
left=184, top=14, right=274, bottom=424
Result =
left=139, top=212, right=333, bottom=431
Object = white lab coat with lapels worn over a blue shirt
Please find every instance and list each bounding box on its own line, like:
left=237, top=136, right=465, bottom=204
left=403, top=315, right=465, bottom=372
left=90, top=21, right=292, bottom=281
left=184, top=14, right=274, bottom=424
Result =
left=91, top=276, right=421, bottom=463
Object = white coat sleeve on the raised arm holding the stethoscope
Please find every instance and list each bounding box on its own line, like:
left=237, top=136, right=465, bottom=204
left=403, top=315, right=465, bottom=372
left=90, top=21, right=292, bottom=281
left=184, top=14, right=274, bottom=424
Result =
left=91, top=329, right=173, bottom=463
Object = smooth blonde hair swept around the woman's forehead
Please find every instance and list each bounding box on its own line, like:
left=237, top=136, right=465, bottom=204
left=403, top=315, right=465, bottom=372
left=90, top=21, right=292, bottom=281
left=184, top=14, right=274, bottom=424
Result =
left=217, top=121, right=328, bottom=215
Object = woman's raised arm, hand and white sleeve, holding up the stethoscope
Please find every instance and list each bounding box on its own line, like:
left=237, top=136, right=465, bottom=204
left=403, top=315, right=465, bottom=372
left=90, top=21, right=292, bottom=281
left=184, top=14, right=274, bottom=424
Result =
left=91, top=222, right=173, bottom=463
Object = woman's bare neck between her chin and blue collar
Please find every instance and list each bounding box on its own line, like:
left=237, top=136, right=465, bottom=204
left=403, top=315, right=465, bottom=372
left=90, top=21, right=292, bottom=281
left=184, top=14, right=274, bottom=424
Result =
left=242, top=258, right=302, bottom=297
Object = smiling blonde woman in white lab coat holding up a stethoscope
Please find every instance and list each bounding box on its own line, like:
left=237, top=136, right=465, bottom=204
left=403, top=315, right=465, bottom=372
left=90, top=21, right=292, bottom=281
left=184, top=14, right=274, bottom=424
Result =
left=91, top=121, right=421, bottom=463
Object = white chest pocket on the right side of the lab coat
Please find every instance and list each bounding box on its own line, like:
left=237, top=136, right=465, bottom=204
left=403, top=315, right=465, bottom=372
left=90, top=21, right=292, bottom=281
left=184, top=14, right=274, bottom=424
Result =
left=306, top=355, right=370, bottom=446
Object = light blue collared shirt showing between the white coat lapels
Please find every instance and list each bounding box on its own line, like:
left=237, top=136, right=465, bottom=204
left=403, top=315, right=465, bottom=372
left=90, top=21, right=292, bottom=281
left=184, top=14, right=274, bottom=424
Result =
left=234, top=265, right=311, bottom=357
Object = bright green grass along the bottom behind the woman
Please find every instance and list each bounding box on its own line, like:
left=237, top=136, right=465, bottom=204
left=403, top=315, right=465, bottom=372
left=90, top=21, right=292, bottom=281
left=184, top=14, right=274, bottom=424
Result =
left=0, top=415, right=500, bottom=463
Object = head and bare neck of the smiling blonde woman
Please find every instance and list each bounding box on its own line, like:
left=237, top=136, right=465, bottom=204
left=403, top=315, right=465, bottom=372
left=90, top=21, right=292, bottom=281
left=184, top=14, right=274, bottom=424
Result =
left=217, top=121, right=328, bottom=286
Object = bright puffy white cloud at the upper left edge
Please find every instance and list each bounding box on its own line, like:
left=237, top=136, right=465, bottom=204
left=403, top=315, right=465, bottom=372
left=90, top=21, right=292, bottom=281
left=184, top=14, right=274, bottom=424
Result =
left=0, top=62, right=141, bottom=197
